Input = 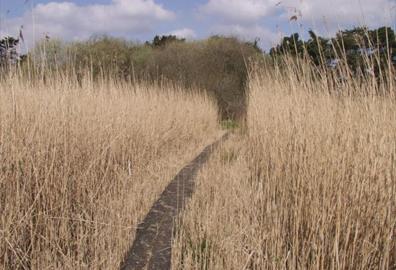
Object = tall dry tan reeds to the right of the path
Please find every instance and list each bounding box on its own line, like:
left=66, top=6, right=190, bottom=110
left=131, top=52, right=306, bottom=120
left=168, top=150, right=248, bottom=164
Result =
left=173, top=62, right=396, bottom=269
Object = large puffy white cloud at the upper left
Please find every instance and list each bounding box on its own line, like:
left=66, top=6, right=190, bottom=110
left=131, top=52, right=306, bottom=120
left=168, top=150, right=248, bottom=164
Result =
left=3, top=0, right=175, bottom=47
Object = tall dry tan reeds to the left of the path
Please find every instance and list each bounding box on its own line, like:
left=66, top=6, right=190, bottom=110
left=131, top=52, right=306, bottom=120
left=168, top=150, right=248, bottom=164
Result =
left=0, top=74, right=218, bottom=269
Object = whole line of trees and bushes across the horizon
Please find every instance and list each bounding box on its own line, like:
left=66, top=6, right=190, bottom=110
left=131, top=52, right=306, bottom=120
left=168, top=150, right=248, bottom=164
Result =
left=0, top=27, right=396, bottom=119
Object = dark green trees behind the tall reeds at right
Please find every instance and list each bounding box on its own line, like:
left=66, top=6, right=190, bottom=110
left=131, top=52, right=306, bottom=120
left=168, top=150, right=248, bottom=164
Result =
left=270, top=26, right=396, bottom=71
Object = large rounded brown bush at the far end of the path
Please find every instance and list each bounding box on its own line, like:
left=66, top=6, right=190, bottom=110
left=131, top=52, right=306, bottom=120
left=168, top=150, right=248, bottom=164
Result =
left=144, top=36, right=261, bottom=120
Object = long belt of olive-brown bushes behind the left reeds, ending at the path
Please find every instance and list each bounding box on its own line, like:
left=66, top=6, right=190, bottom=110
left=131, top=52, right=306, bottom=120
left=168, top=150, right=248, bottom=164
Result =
left=26, top=36, right=261, bottom=119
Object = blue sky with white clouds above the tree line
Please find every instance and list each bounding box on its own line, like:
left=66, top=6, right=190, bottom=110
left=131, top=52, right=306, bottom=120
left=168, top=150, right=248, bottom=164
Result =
left=0, top=0, right=396, bottom=49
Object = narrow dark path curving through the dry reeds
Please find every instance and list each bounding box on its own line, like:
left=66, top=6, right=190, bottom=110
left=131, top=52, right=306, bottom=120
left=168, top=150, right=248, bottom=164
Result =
left=120, top=133, right=228, bottom=270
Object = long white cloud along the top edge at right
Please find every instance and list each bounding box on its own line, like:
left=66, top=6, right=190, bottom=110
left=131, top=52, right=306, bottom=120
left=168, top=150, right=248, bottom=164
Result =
left=203, top=0, right=396, bottom=27
